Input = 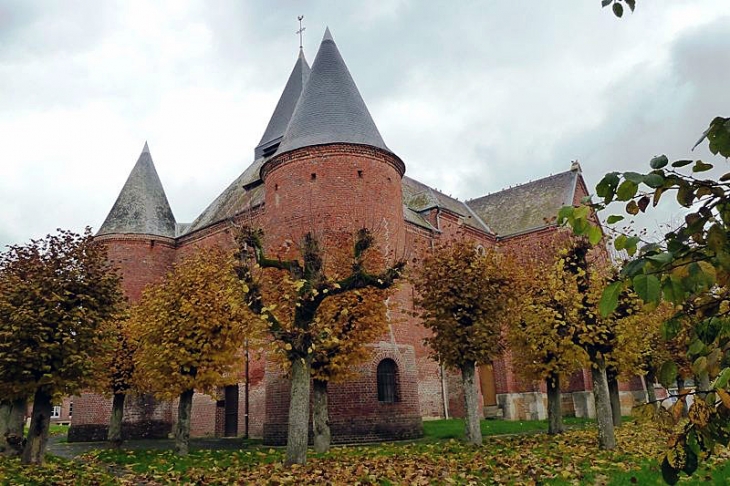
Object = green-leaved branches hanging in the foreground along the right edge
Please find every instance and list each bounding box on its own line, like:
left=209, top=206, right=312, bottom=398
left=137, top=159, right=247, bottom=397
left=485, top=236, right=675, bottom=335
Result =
left=560, top=117, right=730, bottom=483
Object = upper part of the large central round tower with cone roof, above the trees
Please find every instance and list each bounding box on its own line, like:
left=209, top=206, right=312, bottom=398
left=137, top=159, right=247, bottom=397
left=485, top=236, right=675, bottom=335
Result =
left=261, top=30, right=405, bottom=260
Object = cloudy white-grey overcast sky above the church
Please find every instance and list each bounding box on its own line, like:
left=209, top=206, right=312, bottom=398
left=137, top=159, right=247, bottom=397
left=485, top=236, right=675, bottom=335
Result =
left=0, top=0, right=730, bottom=245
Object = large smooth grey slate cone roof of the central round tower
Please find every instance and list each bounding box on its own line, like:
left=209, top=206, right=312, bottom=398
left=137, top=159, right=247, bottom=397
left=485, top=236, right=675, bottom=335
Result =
left=276, top=28, right=390, bottom=154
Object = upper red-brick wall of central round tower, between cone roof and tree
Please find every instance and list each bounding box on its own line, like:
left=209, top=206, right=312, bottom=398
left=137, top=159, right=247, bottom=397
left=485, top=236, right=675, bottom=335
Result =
left=261, top=144, right=405, bottom=261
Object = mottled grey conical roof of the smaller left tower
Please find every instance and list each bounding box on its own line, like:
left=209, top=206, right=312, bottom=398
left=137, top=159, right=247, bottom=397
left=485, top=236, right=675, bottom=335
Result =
left=97, top=142, right=175, bottom=238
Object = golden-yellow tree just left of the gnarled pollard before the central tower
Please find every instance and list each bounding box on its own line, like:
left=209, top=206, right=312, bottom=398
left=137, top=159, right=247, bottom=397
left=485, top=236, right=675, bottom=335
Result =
left=130, top=248, right=255, bottom=455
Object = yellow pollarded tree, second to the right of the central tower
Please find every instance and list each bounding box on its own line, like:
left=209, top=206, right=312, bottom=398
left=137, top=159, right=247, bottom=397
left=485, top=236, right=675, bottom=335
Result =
left=508, top=250, right=587, bottom=434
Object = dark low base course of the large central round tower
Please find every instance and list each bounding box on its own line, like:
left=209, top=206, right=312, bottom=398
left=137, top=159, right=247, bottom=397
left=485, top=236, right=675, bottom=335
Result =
left=263, top=416, right=423, bottom=445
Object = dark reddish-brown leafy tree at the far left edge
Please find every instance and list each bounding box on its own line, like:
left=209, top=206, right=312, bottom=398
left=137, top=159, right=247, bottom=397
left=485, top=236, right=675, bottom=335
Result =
left=0, top=228, right=123, bottom=464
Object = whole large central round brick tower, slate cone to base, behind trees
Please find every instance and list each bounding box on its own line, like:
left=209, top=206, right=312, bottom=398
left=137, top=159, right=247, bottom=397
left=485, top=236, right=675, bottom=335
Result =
left=260, top=29, right=422, bottom=444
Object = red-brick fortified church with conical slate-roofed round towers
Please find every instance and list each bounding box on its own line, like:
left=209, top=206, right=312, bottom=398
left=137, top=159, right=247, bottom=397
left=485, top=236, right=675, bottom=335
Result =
left=69, top=29, right=640, bottom=444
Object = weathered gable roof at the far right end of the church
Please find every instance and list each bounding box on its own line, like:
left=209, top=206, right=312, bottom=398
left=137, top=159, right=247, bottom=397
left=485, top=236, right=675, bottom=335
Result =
left=466, top=171, right=580, bottom=236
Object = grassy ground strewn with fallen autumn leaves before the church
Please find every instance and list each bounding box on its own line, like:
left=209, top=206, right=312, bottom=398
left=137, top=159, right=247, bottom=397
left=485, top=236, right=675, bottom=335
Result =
left=0, top=423, right=730, bottom=485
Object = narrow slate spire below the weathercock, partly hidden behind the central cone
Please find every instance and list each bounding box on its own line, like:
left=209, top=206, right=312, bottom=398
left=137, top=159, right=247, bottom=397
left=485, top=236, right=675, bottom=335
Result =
left=254, top=49, right=310, bottom=159
